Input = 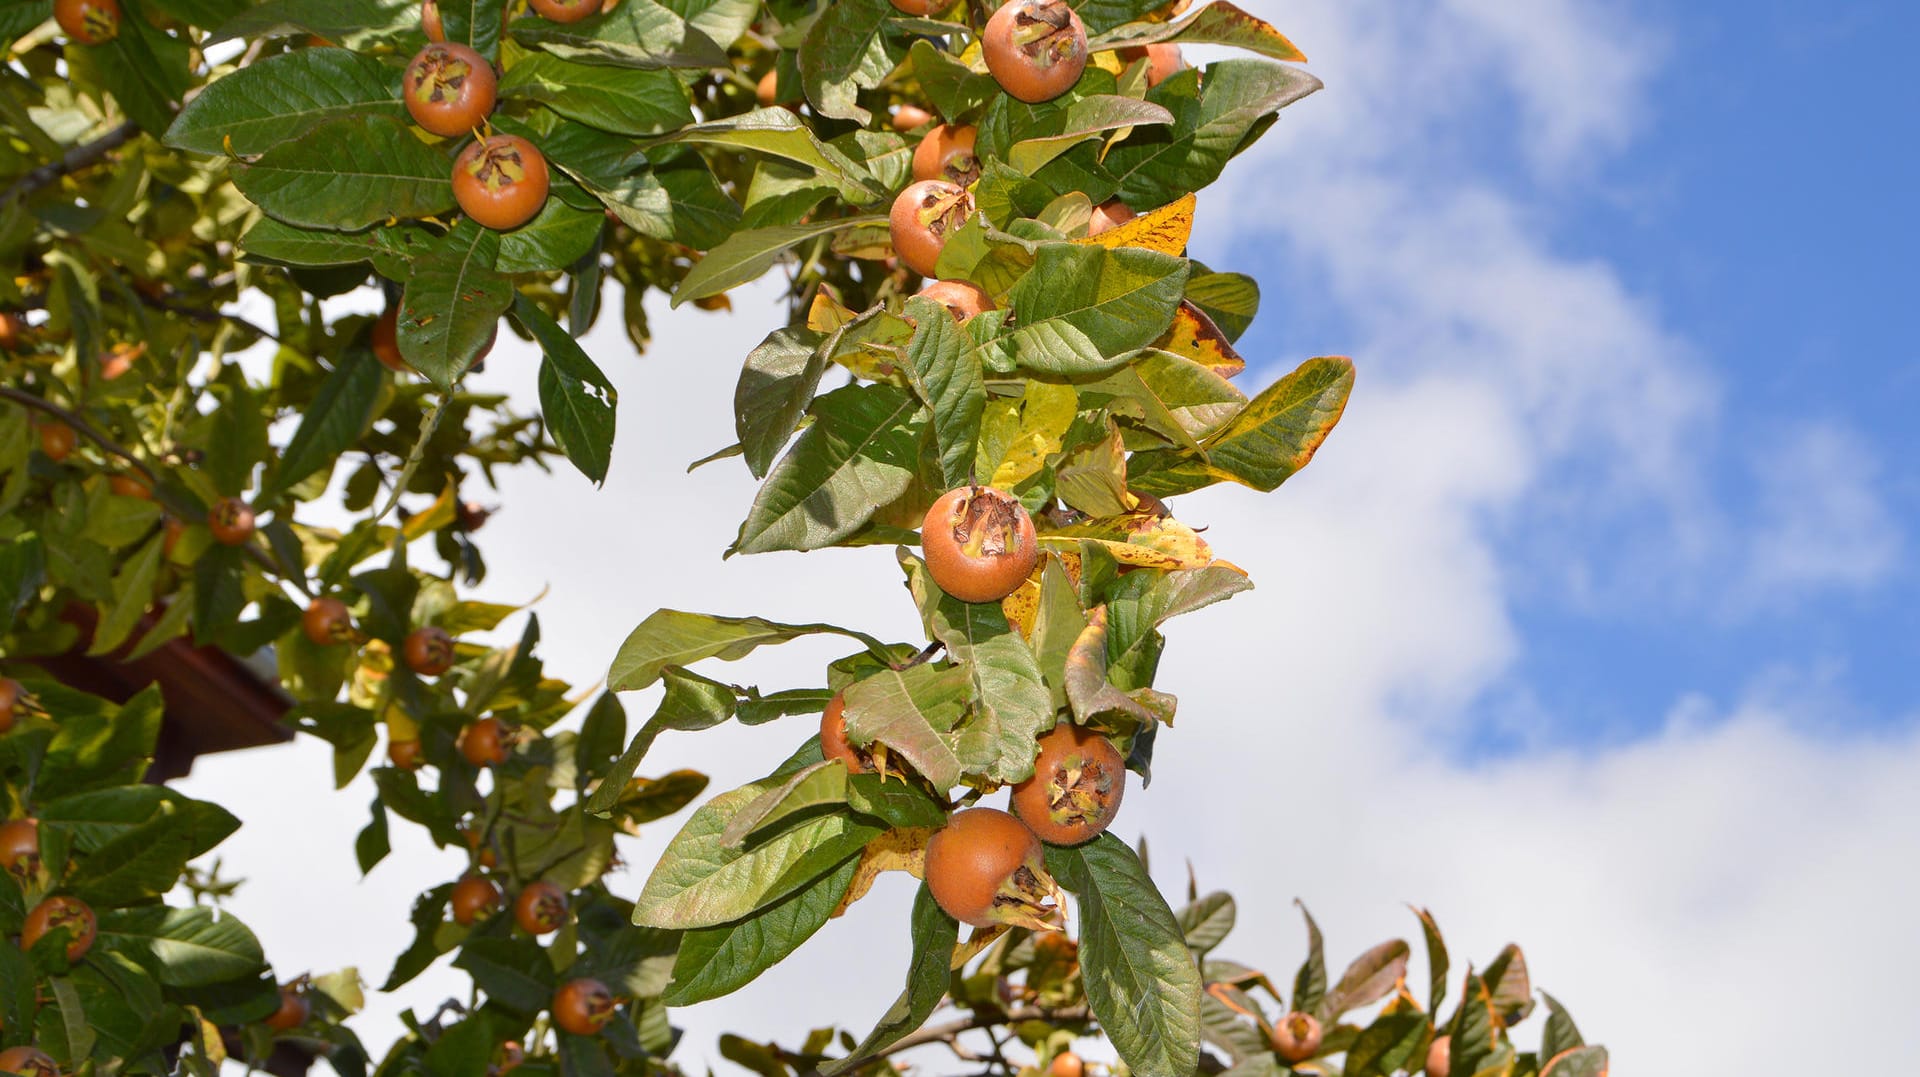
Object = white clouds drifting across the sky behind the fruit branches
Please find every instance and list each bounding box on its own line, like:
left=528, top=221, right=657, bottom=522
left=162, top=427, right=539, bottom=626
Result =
left=172, top=0, right=1920, bottom=1075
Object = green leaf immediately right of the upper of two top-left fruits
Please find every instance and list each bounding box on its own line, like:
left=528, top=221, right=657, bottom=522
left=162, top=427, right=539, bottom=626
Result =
left=499, top=52, right=693, bottom=134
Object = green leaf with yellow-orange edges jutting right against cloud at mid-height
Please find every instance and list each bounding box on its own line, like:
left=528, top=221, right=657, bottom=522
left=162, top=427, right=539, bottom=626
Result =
left=1129, top=355, right=1354, bottom=497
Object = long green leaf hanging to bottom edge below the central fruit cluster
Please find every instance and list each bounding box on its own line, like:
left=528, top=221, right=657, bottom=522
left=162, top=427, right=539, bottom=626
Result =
left=1046, top=833, right=1200, bottom=1073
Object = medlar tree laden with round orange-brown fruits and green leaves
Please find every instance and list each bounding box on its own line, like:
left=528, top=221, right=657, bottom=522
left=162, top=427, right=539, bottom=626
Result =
left=0, top=0, right=1607, bottom=1077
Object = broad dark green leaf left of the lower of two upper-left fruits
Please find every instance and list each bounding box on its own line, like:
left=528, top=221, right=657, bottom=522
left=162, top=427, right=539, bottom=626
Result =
left=230, top=113, right=453, bottom=232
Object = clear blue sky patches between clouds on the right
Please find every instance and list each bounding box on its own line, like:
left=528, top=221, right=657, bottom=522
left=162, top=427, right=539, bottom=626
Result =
left=1235, top=2, right=1920, bottom=754
